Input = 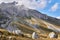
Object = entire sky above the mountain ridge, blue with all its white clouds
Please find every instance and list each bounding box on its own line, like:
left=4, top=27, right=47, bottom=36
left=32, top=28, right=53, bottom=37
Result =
left=0, top=0, right=60, bottom=19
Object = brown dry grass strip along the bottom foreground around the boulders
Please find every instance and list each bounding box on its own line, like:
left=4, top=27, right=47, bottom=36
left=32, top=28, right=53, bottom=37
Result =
left=0, top=29, right=60, bottom=40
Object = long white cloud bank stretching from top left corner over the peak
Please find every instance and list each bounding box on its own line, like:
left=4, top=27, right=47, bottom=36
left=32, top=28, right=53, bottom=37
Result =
left=0, top=0, right=51, bottom=9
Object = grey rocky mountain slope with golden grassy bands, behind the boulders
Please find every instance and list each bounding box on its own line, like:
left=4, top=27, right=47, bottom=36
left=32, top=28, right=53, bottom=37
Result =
left=0, top=1, right=60, bottom=40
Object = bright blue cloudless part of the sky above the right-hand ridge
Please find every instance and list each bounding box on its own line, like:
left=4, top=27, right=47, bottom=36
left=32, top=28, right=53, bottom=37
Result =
left=37, top=0, right=60, bottom=18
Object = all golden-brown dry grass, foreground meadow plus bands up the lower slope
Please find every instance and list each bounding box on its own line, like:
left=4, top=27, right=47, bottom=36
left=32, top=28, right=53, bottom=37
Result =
left=0, top=18, right=60, bottom=40
